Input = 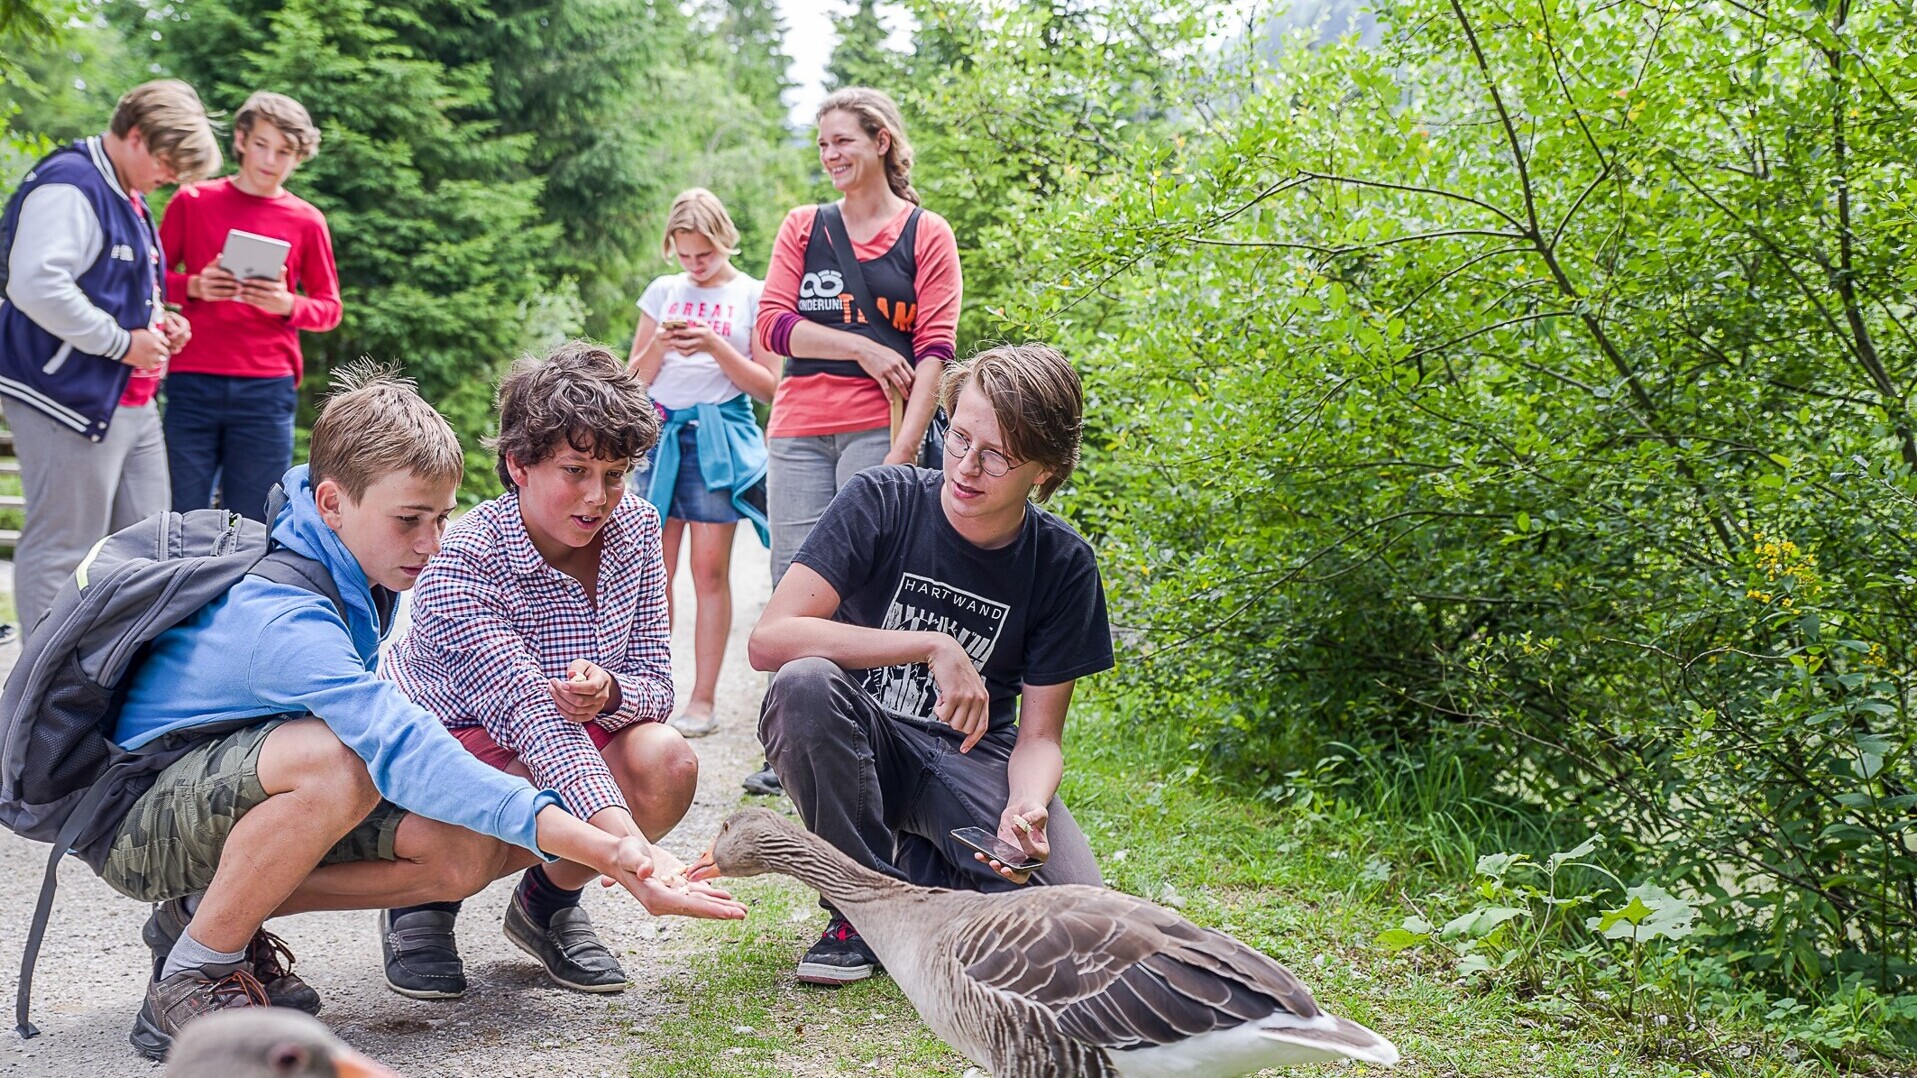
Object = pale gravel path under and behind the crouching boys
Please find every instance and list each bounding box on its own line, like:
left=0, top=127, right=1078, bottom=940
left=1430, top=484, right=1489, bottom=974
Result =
left=0, top=526, right=771, bottom=1078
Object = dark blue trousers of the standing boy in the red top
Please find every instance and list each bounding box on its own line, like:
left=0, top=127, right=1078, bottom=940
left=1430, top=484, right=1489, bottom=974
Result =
left=161, top=374, right=299, bottom=524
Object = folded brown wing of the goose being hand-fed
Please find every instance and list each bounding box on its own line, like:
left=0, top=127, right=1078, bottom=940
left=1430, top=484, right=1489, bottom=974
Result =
left=955, top=886, right=1319, bottom=1051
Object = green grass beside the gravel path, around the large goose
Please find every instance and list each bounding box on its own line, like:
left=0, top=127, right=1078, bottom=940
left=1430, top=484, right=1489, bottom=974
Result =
left=631, top=690, right=1904, bottom=1078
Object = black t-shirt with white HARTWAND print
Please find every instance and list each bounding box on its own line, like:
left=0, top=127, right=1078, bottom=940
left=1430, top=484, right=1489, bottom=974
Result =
left=796, top=464, right=1112, bottom=727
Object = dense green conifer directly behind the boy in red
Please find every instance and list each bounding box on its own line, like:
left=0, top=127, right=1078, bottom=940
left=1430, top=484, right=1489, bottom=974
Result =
left=123, top=0, right=560, bottom=493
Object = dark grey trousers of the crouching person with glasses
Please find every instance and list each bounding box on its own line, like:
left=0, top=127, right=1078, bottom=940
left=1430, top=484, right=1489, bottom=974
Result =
left=759, top=658, right=1104, bottom=890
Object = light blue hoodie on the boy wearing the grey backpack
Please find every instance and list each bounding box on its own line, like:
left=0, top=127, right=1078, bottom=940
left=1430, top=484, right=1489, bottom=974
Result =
left=113, top=464, right=560, bottom=855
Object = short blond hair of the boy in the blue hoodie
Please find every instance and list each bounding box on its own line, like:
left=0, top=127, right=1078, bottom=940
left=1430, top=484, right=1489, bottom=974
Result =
left=307, top=361, right=466, bottom=503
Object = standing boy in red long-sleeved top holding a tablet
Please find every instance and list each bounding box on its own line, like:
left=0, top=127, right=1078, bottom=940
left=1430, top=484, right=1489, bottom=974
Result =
left=159, top=92, right=339, bottom=520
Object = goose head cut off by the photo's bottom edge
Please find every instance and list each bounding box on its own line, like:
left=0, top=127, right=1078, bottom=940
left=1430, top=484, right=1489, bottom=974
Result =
left=167, top=1007, right=399, bottom=1078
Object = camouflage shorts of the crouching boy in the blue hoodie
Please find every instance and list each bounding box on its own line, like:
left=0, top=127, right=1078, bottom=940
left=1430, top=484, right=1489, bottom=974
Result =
left=100, top=719, right=406, bottom=902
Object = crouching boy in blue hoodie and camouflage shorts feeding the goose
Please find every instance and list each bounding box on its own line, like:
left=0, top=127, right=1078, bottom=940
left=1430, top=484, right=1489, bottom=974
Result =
left=102, top=364, right=744, bottom=1059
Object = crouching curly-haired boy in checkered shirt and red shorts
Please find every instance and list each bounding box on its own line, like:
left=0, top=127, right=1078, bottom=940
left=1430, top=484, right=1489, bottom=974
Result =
left=381, top=341, right=700, bottom=999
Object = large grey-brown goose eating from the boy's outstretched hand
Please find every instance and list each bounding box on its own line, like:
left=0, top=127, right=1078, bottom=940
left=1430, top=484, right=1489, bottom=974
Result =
left=690, top=809, right=1397, bottom=1078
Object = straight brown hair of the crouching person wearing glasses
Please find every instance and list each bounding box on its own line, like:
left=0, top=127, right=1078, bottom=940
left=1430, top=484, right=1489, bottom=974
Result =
left=939, top=343, right=1085, bottom=501
